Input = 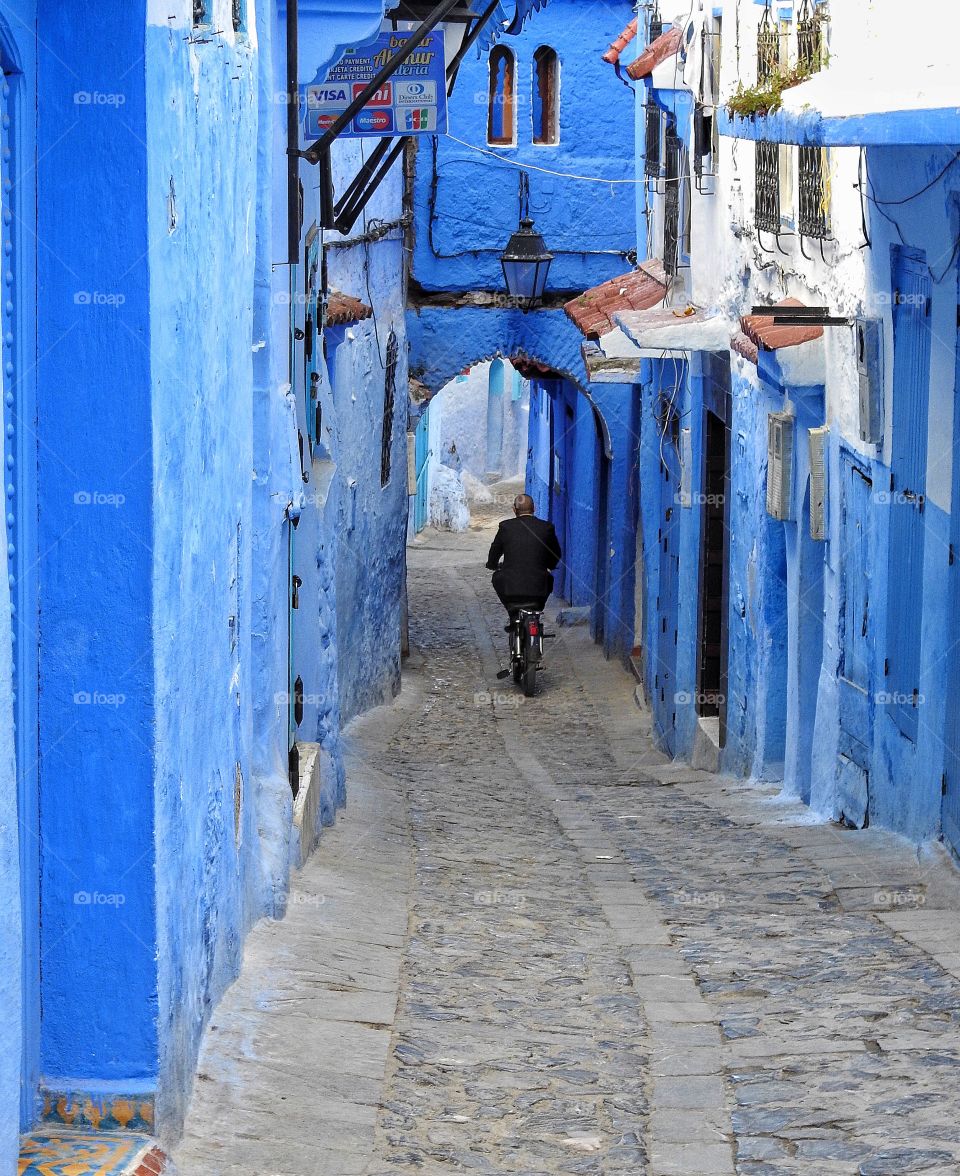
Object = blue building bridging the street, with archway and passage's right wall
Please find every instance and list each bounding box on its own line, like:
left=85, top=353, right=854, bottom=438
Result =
left=407, top=0, right=636, bottom=649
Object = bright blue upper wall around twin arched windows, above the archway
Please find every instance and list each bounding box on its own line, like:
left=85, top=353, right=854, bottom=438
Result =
left=413, top=0, right=635, bottom=292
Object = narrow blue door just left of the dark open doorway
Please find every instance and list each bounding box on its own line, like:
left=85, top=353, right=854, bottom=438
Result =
left=653, top=365, right=680, bottom=755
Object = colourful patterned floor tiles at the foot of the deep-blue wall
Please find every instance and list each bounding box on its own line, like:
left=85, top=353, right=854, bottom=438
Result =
left=19, top=1131, right=164, bottom=1176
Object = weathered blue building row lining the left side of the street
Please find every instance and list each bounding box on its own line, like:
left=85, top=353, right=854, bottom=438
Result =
left=0, top=0, right=418, bottom=1170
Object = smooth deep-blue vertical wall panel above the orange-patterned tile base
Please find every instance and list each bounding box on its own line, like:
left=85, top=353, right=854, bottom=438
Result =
left=38, top=2, right=158, bottom=1088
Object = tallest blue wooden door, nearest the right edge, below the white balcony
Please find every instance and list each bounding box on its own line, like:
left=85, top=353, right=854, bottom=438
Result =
left=884, top=249, right=931, bottom=741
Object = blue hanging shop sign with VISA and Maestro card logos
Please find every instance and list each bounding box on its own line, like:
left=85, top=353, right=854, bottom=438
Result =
left=304, top=27, right=447, bottom=139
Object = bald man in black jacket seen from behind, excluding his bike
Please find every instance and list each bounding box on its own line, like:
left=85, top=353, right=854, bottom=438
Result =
left=487, top=494, right=562, bottom=621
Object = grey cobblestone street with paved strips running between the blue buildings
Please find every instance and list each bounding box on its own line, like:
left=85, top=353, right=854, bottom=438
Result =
left=174, top=524, right=960, bottom=1176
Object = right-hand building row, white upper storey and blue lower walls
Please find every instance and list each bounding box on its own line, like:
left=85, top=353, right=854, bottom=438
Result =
left=531, top=0, right=960, bottom=865
